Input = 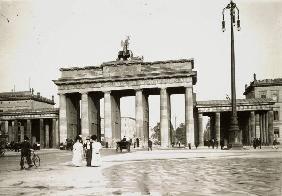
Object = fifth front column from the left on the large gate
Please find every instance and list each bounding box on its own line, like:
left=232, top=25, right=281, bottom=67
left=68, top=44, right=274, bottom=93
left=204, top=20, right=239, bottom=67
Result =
left=160, top=88, right=169, bottom=148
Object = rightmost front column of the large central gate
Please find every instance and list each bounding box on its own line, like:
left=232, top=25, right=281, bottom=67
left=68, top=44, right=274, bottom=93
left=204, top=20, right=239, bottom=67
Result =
left=185, top=88, right=195, bottom=146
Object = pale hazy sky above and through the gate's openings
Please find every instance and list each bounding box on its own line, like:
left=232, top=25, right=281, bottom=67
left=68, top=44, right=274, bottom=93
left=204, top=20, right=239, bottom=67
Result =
left=0, top=0, right=282, bottom=125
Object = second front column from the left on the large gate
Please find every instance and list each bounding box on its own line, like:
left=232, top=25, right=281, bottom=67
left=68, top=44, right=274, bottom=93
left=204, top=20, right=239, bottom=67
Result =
left=81, top=93, right=90, bottom=138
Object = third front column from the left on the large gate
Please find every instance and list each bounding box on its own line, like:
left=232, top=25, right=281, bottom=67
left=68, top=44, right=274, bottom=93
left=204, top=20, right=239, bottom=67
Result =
left=104, top=91, right=113, bottom=147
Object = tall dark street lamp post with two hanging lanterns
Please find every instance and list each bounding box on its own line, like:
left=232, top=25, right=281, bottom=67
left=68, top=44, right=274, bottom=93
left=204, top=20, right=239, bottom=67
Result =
left=222, top=0, right=242, bottom=148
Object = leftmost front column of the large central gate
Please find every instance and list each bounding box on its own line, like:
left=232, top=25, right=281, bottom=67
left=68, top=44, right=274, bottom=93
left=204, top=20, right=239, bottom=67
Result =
left=59, top=94, right=68, bottom=143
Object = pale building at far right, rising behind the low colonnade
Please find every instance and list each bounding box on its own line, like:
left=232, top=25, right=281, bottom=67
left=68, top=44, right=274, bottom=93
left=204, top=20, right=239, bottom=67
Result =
left=244, top=74, right=282, bottom=143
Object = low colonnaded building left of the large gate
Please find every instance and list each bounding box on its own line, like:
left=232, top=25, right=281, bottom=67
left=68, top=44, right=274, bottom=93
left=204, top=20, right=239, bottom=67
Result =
left=0, top=90, right=59, bottom=148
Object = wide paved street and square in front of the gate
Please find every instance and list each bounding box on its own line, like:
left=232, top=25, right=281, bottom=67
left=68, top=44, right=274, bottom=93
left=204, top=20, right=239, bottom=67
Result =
left=0, top=148, right=282, bottom=195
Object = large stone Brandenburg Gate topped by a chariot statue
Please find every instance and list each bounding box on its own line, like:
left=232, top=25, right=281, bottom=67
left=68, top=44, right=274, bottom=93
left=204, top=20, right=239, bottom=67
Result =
left=54, top=48, right=197, bottom=148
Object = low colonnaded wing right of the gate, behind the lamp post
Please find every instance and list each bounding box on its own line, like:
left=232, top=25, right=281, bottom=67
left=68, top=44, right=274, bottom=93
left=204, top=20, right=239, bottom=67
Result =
left=195, top=98, right=275, bottom=146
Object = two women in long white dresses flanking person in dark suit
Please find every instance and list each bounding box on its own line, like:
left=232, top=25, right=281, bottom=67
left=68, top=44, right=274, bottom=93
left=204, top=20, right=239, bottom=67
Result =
left=72, top=135, right=102, bottom=167
